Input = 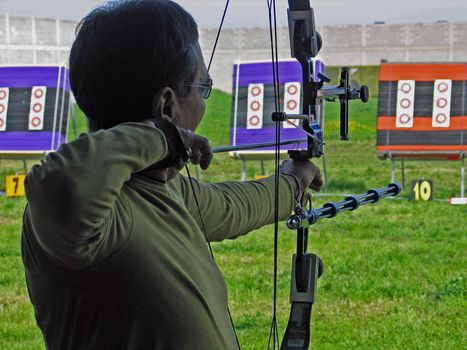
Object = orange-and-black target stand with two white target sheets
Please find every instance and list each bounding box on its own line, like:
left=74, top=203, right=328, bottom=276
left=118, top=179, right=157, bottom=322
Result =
left=376, top=63, right=467, bottom=198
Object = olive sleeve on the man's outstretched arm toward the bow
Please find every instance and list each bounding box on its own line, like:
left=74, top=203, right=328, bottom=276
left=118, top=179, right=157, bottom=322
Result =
left=177, top=175, right=294, bottom=241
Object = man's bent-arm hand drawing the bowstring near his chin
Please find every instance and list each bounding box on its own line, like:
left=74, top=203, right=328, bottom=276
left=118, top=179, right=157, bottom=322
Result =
left=177, top=127, right=213, bottom=170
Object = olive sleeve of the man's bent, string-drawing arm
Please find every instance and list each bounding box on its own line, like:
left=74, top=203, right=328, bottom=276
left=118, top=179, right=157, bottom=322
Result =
left=25, top=122, right=168, bottom=268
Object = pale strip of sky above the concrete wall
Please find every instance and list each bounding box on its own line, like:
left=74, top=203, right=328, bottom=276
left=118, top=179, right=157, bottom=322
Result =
left=0, top=0, right=467, bottom=28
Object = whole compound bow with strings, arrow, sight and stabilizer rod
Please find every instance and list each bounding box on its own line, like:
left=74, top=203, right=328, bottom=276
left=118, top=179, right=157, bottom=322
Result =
left=199, top=0, right=401, bottom=350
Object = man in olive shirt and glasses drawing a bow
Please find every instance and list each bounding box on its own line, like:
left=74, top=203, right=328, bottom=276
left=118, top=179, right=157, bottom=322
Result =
left=22, top=0, right=321, bottom=350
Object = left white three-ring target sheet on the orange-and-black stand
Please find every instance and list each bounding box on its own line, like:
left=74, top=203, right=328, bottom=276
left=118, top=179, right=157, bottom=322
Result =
left=396, top=80, right=415, bottom=128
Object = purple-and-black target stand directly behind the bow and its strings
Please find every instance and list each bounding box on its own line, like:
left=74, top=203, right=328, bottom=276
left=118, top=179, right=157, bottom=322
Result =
left=229, top=60, right=327, bottom=183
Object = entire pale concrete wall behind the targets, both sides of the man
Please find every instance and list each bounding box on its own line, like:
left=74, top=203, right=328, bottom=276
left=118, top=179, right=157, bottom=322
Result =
left=0, top=15, right=467, bottom=92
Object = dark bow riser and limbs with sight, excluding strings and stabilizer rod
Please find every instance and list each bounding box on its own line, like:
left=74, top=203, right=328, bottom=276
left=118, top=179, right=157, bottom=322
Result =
left=282, top=0, right=368, bottom=350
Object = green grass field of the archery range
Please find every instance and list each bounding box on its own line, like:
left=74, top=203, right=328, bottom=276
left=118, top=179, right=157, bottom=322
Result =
left=0, top=92, right=467, bottom=350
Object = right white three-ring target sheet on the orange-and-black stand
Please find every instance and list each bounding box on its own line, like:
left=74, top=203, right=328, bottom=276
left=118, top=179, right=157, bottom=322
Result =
left=431, top=79, right=452, bottom=128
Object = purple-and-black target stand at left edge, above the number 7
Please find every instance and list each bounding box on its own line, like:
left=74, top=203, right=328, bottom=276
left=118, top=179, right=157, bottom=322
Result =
left=0, top=65, right=74, bottom=172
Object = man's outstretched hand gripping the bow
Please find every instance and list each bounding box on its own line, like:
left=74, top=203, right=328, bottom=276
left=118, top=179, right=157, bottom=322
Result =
left=280, top=159, right=323, bottom=197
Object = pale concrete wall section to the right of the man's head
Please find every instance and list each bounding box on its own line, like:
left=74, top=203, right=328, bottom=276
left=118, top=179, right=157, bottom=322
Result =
left=201, top=22, right=467, bottom=91
